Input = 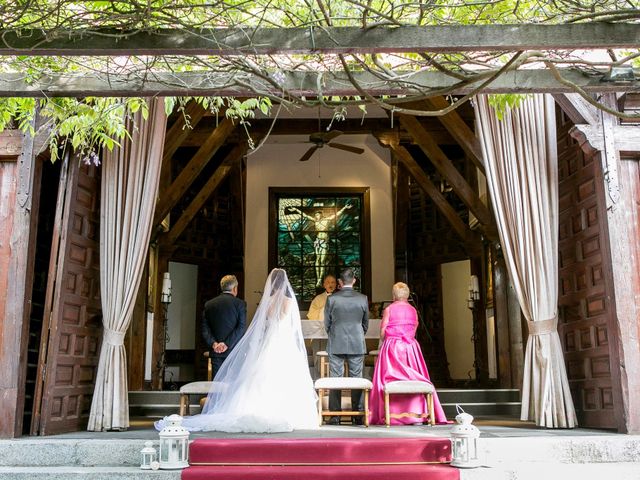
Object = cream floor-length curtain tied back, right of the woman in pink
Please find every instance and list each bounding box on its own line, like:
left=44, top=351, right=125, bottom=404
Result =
left=475, top=95, right=577, bottom=428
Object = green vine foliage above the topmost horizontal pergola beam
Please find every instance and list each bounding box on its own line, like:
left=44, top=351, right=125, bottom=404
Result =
left=0, top=0, right=638, bottom=30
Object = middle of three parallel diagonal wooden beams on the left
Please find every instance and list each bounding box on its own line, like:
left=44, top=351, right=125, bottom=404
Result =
left=153, top=118, right=235, bottom=230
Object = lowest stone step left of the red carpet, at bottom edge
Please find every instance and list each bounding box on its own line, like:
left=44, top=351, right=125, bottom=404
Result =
left=0, top=466, right=181, bottom=480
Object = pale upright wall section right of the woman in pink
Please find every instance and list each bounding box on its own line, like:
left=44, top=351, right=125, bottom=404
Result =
left=442, top=260, right=475, bottom=380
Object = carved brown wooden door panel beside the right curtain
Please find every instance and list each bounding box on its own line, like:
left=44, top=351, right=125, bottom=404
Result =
left=557, top=108, right=620, bottom=428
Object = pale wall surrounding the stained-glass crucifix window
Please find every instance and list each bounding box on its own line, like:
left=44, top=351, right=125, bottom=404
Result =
left=245, top=135, right=394, bottom=318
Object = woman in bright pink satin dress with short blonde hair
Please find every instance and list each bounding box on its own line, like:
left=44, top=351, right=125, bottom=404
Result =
left=369, top=282, right=447, bottom=425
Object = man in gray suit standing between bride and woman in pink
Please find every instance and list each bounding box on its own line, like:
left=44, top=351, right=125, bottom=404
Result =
left=324, top=268, right=369, bottom=424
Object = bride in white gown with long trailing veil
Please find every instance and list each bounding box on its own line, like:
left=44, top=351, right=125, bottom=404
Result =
left=156, top=268, right=318, bottom=433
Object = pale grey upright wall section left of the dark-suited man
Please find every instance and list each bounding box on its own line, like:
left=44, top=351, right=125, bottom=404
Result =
left=167, top=262, right=200, bottom=350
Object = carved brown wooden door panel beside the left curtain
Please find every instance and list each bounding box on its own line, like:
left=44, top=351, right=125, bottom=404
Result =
left=31, top=157, right=102, bottom=435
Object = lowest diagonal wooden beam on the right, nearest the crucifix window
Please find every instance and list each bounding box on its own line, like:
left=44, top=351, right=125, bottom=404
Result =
left=389, top=143, right=479, bottom=250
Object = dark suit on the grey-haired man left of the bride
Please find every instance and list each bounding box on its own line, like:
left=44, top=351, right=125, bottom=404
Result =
left=202, top=292, right=247, bottom=375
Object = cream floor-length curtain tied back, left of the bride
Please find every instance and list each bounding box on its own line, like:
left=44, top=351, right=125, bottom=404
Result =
left=87, top=98, right=166, bottom=431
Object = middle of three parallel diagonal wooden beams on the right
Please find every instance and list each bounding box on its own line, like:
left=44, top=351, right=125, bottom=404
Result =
left=400, top=115, right=493, bottom=229
